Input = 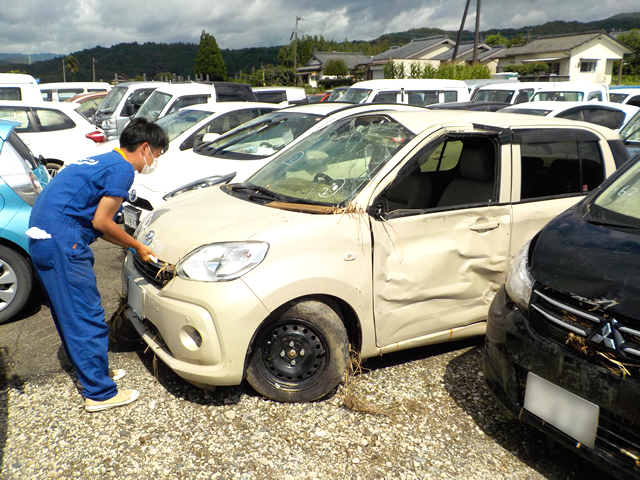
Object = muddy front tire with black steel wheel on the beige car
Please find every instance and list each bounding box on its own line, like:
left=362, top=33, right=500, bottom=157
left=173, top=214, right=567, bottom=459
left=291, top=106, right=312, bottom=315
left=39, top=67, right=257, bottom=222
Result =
left=246, top=300, right=349, bottom=402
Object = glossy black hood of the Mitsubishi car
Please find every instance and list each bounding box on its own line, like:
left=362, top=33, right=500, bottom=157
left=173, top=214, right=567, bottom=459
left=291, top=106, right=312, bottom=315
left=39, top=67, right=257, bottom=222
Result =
left=531, top=206, right=640, bottom=320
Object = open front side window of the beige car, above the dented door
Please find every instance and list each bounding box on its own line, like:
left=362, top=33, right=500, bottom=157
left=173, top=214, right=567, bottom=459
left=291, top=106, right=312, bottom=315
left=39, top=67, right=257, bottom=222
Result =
left=386, top=136, right=499, bottom=212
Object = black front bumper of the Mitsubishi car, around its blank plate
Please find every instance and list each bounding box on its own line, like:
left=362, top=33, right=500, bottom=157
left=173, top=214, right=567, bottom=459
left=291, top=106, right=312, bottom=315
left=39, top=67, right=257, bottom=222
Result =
left=485, top=287, right=640, bottom=479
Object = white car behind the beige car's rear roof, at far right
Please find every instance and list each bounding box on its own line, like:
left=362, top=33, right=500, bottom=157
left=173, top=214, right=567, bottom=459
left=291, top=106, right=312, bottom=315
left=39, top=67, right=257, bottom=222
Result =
left=499, top=101, right=640, bottom=130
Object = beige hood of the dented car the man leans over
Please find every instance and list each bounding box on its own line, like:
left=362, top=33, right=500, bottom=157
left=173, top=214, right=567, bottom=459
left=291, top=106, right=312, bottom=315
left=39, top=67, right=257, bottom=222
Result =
left=136, top=187, right=300, bottom=264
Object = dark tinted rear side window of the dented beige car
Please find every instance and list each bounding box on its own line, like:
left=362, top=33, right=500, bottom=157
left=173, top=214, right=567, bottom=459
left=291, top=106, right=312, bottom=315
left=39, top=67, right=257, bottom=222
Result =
left=520, top=141, right=604, bottom=200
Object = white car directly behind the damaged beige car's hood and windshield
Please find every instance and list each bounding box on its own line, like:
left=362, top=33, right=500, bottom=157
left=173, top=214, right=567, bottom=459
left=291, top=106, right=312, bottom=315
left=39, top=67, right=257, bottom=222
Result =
left=123, top=103, right=424, bottom=232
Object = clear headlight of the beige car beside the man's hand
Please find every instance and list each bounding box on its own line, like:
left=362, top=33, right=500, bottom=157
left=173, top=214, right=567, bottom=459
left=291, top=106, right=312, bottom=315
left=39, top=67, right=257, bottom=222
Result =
left=177, top=242, right=269, bottom=282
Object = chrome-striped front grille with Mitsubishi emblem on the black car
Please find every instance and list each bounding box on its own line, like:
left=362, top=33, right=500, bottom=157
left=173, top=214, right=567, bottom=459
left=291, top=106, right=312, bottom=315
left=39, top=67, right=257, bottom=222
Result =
left=531, top=288, right=640, bottom=366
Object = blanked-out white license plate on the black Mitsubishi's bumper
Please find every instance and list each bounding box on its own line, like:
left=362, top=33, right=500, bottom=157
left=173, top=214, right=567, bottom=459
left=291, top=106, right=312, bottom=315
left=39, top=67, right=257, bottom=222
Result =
left=524, top=372, right=600, bottom=448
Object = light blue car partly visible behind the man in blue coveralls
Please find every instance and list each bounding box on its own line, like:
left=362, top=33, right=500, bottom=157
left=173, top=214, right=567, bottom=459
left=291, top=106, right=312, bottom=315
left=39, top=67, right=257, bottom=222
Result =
left=0, top=120, right=51, bottom=323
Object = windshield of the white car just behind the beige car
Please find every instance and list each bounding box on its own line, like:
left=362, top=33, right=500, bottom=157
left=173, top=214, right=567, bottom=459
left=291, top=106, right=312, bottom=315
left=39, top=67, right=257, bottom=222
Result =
left=194, top=111, right=324, bottom=160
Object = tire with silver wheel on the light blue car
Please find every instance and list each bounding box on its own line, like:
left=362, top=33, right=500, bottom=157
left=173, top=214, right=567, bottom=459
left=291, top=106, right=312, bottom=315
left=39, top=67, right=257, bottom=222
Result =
left=0, top=245, right=34, bottom=323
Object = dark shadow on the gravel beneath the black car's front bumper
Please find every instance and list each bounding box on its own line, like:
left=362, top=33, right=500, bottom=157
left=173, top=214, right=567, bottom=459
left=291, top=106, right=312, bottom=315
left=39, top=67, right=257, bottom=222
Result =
left=444, top=345, right=606, bottom=480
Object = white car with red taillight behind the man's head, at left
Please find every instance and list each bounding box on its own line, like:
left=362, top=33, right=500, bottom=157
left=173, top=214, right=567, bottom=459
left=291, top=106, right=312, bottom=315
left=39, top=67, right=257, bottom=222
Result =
left=0, top=100, right=105, bottom=177
